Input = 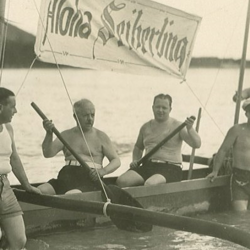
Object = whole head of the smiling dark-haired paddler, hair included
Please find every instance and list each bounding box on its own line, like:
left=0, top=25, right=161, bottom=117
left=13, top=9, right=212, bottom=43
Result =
left=152, top=94, right=172, bottom=122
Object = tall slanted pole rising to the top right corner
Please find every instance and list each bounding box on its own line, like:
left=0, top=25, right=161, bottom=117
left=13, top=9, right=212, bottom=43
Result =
left=234, top=0, right=250, bottom=124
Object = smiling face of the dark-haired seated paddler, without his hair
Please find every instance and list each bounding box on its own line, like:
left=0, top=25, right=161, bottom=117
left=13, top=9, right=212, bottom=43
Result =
left=152, top=98, right=171, bottom=122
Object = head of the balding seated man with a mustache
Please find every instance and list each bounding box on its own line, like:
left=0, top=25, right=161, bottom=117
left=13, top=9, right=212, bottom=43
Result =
left=74, top=99, right=95, bottom=131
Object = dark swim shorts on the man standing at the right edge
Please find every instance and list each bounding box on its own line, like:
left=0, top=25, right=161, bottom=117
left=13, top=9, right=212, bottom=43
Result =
left=230, top=168, right=250, bottom=201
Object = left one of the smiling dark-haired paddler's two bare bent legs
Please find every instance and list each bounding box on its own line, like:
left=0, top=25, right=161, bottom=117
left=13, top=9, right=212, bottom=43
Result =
left=116, top=170, right=144, bottom=187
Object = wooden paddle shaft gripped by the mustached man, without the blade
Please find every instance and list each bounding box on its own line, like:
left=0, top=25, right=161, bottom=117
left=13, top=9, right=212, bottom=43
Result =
left=31, top=102, right=90, bottom=172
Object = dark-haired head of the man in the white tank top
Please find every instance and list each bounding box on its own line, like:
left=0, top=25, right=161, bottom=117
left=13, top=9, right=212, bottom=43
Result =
left=0, top=87, right=17, bottom=124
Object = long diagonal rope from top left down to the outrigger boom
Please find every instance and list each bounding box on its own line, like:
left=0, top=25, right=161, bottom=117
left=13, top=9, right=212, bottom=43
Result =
left=33, top=0, right=109, bottom=201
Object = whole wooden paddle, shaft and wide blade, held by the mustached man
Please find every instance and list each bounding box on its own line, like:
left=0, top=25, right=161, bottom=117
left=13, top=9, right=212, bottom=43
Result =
left=31, top=102, right=152, bottom=232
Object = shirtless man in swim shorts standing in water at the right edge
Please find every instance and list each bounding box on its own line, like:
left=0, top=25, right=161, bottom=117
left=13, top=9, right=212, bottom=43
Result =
left=207, top=99, right=250, bottom=212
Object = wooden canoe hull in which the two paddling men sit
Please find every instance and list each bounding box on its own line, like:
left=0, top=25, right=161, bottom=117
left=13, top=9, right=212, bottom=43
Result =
left=13, top=155, right=230, bottom=235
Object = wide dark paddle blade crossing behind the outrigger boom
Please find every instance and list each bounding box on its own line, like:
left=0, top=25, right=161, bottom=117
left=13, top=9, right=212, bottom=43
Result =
left=101, top=185, right=153, bottom=232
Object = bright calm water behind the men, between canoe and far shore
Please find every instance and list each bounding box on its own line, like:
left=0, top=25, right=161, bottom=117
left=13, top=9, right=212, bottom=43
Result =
left=2, top=68, right=250, bottom=184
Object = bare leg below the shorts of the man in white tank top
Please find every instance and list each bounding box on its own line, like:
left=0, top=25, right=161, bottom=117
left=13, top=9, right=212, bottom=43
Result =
left=1, top=215, right=27, bottom=250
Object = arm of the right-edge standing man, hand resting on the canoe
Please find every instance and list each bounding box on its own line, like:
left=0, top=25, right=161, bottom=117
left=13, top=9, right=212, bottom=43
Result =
left=207, top=125, right=238, bottom=182
